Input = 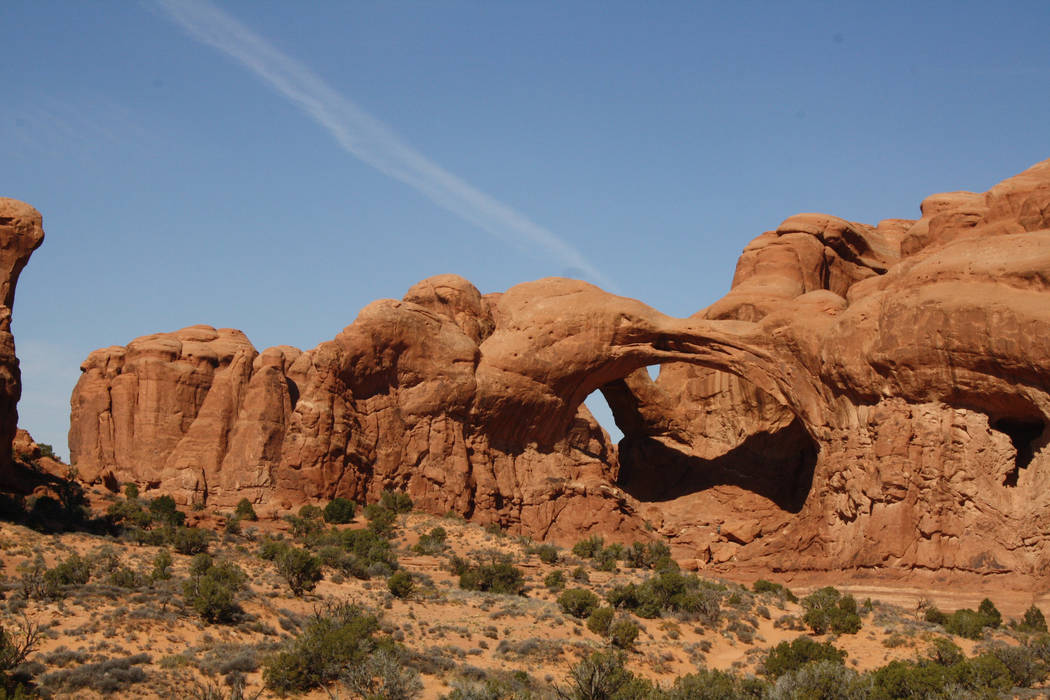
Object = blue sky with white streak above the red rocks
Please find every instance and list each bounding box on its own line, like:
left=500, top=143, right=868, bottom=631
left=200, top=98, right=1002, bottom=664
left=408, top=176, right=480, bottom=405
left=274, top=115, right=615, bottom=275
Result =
left=0, top=0, right=1050, bottom=454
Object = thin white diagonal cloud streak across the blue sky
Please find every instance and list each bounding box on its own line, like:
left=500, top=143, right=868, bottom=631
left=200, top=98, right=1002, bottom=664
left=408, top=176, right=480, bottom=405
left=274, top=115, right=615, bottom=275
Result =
left=156, top=0, right=611, bottom=288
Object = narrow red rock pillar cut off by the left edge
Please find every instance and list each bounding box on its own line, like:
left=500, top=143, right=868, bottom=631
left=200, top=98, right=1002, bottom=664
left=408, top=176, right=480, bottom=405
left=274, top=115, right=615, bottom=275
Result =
left=0, top=197, right=44, bottom=482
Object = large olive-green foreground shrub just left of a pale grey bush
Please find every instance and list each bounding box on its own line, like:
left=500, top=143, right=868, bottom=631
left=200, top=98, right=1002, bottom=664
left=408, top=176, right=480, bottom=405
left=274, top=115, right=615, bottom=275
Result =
left=263, top=603, right=393, bottom=694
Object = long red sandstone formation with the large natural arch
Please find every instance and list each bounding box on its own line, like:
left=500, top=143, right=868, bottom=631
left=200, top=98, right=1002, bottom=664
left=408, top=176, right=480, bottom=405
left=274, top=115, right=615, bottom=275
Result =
left=70, top=162, right=1050, bottom=578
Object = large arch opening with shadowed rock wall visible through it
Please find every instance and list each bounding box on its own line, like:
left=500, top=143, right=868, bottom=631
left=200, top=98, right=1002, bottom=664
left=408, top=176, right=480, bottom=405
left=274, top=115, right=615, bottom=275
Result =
left=602, top=364, right=819, bottom=513
